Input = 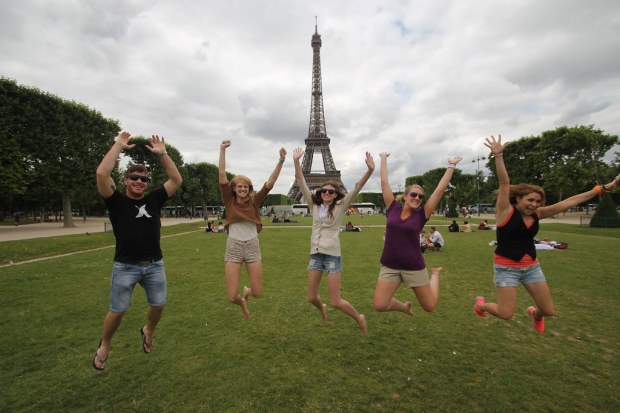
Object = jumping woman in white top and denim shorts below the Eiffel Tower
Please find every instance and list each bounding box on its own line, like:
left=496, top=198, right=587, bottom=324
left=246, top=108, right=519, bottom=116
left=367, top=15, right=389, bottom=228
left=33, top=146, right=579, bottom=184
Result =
left=293, top=148, right=375, bottom=335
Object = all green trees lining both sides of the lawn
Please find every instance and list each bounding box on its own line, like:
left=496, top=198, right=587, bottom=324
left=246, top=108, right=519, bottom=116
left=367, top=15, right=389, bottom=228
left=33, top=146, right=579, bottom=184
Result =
left=0, top=78, right=620, bottom=226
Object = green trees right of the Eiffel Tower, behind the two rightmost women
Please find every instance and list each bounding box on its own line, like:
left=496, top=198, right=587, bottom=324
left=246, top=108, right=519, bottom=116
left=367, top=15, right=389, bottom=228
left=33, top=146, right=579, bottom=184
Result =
left=406, top=125, right=620, bottom=216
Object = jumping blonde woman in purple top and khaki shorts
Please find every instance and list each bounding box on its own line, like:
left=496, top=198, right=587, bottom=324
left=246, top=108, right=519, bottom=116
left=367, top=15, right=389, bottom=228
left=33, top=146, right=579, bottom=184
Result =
left=373, top=152, right=463, bottom=315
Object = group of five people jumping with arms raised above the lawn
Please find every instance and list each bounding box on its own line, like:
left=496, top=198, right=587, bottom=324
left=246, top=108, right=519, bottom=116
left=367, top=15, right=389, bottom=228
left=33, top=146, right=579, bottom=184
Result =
left=92, top=132, right=620, bottom=370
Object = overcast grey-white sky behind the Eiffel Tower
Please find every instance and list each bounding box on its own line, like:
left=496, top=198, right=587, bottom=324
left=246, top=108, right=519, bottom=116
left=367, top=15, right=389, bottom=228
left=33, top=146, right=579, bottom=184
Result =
left=0, top=0, right=620, bottom=193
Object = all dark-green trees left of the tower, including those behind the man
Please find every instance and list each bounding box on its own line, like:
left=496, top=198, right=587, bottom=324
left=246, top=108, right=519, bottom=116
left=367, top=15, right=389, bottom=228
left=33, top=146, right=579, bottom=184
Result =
left=0, top=77, right=232, bottom=227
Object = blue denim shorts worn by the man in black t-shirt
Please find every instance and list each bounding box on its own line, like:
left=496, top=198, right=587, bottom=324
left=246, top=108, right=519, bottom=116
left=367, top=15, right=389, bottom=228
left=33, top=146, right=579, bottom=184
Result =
left=110, top=260, right=167, bottom=313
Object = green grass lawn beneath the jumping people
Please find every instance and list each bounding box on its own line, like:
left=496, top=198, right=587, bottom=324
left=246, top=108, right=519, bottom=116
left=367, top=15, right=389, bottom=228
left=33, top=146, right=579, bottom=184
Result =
left=0, top=216, right=620, bottom=412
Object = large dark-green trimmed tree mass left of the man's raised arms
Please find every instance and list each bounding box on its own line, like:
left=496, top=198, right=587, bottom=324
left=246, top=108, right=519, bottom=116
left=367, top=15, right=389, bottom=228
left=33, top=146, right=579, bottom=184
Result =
left=0, top=78, right=119, bottom=226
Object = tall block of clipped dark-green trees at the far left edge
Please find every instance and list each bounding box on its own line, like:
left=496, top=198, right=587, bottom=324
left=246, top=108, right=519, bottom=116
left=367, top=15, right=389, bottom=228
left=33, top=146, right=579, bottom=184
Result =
left=0, top=78, right=119, bottom=227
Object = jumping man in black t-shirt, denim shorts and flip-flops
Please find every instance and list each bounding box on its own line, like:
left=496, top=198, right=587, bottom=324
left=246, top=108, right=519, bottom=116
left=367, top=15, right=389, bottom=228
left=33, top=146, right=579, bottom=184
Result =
left=93, top=132, right=183, bottom=370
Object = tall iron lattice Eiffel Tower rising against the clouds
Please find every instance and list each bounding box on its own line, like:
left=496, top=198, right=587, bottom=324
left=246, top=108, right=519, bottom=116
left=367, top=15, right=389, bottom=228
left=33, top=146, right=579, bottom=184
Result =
left=288, top=23, right=347, bottom=201
